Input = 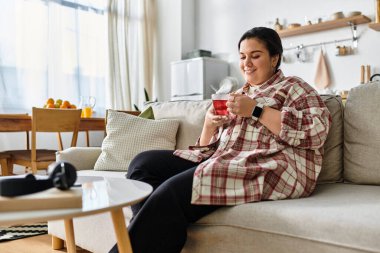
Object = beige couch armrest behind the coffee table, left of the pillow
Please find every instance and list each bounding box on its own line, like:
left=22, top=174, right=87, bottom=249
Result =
left=56, top=147, right=102, bottom=170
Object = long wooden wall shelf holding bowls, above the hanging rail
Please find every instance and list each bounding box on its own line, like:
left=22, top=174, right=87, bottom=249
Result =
left=278, top=15, right=371, bottom=38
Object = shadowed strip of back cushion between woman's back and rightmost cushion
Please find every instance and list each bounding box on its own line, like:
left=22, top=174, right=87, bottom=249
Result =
left=318, top=95, right=343, bottom=183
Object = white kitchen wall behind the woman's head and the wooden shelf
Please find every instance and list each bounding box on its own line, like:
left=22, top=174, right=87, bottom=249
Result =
left=195, top=0, right=380, bottom=90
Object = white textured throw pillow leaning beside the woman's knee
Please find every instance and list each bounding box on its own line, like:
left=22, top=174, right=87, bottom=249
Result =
left=94, top=110, right=179, bottom=171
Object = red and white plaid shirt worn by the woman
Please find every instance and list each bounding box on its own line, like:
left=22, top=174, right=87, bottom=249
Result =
left=174, top=71, right=331, bottom=205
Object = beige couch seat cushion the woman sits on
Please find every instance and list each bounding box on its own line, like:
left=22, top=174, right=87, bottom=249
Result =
left=196, top=183, right=380, bottom=252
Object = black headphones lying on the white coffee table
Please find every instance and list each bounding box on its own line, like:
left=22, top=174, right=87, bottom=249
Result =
left=0, top=161, right=77, bottom=197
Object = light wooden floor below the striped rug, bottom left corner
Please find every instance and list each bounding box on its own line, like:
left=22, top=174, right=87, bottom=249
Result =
left=0, top=234, right=91, bottom=253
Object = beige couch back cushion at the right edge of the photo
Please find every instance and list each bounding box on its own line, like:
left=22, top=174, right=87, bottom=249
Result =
left=344, top=83, right=380, bottom=184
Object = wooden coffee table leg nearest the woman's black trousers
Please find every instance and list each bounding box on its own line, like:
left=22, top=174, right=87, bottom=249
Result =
left=111, top=208, right=132, bottom=253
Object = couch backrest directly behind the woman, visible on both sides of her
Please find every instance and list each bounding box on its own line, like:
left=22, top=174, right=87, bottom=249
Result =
left=149, top=95, right=343, bottom=183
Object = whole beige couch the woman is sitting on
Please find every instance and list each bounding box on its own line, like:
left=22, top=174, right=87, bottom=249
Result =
left=49, top=84, right=380, bottom=253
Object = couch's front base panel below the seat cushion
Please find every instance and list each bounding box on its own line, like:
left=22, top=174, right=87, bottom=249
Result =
left=186, top=225, right=369, bottom=253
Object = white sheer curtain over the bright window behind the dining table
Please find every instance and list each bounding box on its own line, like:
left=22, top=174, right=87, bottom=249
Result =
left=0, top=0, right=108, bottom=111
